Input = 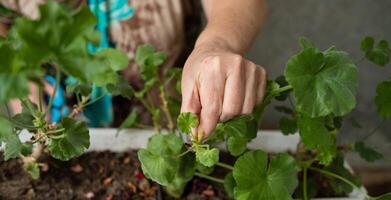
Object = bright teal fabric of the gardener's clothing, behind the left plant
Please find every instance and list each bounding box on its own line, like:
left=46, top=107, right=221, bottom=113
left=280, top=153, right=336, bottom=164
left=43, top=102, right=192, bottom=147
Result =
left=84, top=0, right=134, bottom=127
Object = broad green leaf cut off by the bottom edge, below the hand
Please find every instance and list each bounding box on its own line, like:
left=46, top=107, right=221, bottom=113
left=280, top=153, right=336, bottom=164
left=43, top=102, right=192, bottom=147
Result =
left=233, top=150, right=298, bottom=200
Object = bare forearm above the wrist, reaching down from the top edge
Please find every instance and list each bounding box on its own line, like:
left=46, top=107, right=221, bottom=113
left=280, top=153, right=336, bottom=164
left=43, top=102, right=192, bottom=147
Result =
left=196, top=0, right=266, bottom=55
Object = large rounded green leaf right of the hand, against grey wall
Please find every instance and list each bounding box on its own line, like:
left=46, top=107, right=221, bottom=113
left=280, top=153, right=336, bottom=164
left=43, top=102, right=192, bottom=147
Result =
left=285, top=45, right=358, bottom=117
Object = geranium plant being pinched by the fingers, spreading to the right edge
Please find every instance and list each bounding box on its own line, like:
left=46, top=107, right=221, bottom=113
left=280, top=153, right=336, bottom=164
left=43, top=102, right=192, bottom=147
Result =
left=138, top=37, right=391, bottom=200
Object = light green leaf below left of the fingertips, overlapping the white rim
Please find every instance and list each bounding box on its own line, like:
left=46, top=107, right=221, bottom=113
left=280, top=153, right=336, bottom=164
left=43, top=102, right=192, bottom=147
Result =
left=138, top=134, right=183, bottom=186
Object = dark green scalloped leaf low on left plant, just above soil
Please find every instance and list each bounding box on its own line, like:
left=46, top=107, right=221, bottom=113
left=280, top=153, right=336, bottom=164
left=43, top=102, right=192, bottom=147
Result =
left=48, top=117, right=90, bottom=161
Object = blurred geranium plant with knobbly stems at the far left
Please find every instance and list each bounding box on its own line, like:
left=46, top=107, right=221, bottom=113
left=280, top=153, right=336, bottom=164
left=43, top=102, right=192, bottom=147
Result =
left=0, top=2, right=128, bottom=178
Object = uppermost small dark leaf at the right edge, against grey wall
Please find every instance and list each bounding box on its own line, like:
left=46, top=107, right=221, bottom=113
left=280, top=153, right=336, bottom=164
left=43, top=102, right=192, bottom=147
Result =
left=360, top=36, right=391, bottom=66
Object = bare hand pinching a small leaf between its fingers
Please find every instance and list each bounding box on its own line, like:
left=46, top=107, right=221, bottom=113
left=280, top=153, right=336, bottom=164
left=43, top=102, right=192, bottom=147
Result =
left=181, top=44, right=266, bottom=138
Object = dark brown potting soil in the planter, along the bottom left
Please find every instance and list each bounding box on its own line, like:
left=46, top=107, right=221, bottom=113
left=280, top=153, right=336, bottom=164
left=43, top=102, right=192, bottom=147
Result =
left=0, top=151, right=228, bottom=200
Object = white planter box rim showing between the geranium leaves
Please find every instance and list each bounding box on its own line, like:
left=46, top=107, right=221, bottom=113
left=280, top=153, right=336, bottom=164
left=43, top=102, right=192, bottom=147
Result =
left=7, top=128, right=365, bottom=200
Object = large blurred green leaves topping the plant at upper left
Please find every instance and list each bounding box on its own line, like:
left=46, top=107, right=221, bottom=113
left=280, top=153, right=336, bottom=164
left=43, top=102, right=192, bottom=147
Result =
left=6, top=2, right=128, bottom=85
